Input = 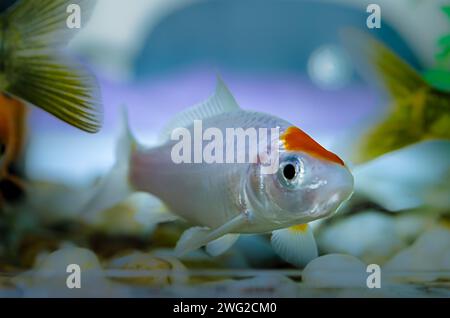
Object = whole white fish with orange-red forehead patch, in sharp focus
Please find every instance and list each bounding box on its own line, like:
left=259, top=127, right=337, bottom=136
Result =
left=91, top=79, right=353, bottom=266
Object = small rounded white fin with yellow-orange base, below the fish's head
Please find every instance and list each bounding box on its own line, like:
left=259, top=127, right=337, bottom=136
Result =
left=271, top=224, right=318, bottom=267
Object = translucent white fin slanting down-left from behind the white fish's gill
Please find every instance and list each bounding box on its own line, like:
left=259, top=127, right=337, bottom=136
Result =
left=175, top=214, right=247, bottom=256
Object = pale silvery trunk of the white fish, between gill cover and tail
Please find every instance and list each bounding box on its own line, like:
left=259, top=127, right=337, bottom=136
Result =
left=130, top=110, right=287, bottom=232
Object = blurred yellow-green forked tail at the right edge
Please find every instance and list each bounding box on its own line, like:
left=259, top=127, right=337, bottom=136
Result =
left=341, top=29, right=450, bottom=163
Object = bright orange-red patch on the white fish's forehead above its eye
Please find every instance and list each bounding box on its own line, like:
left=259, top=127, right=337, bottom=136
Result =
left=280, top=126, right=345, bottom=166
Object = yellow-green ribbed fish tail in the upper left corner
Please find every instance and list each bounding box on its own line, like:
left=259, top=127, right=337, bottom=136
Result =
left=0, top=0, right=102, bottom=133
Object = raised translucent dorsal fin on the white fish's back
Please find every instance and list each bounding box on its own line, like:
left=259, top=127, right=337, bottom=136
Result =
left=159, top=76, right=241, bottom=142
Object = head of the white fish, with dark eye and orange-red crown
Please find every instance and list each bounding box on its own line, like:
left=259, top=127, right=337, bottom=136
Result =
left=248, top=128, right=354, bottom=227
